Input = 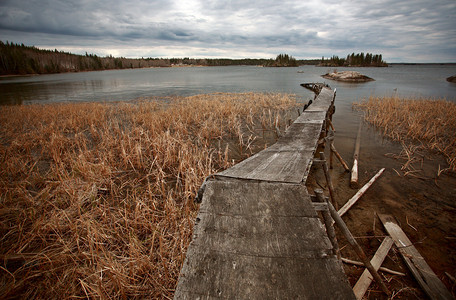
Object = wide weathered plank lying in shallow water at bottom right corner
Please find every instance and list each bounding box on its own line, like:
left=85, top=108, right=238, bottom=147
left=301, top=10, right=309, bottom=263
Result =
left=378, top=214, right=453, bottom=299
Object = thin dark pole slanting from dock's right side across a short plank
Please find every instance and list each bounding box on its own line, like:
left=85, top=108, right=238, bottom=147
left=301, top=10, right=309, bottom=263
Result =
left=326, top=195, right=390, bottom=296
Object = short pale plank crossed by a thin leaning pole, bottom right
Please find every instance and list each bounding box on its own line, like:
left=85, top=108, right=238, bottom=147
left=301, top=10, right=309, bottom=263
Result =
left=353, top=236, right=393, bottom=299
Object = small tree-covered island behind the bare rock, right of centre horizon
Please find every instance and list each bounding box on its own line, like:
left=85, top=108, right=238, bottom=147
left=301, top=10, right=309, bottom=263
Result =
left=319, top=52, right=388, bottom=67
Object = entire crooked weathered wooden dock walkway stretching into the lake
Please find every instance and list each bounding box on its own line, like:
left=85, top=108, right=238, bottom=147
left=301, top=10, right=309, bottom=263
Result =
left=174, top=87, right=355, bottom=299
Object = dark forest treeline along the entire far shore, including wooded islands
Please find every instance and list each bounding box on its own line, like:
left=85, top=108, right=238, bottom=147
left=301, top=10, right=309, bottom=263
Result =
left=0, top=41, right=387, bottom=75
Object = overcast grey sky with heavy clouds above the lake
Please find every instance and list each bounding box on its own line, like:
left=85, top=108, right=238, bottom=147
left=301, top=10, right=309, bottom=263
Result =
left=0, top=0, right=456, bottom=62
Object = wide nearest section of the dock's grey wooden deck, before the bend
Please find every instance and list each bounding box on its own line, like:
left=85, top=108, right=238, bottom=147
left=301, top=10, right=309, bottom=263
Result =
left=175, top=180, right=354, bottom=299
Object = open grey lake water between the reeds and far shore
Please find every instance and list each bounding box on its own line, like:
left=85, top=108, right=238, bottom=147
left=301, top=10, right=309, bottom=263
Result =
left=0, top=65, right=456, bottom=106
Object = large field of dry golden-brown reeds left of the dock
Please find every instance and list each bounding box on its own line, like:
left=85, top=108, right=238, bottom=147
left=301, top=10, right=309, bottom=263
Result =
left=0, top=93, right=296, bottom=299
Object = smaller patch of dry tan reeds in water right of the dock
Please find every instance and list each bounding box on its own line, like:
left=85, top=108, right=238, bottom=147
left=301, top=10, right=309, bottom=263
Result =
left=354, top=97, right=456, bottom=175
